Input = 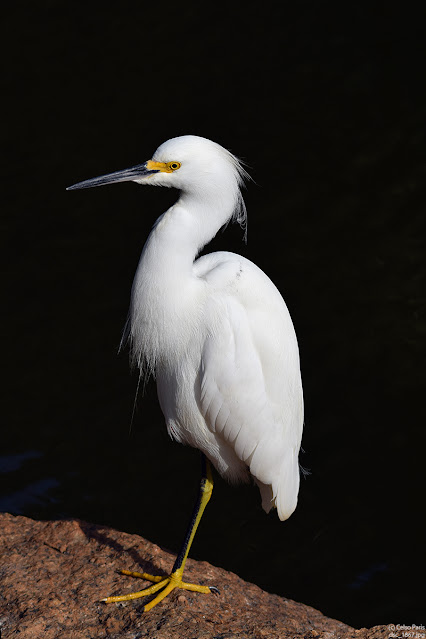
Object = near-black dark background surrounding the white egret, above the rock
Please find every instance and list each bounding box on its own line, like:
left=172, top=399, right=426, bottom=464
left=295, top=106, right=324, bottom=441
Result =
left=0, top=1, right=426, bottom=627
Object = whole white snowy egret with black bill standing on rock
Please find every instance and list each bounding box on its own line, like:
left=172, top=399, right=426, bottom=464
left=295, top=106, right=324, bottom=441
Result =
left=69, top=135, right=303, bottom=611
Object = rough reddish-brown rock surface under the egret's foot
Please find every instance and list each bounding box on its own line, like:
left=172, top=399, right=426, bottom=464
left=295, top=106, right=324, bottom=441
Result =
left=0, top=514, right=389, bottom=639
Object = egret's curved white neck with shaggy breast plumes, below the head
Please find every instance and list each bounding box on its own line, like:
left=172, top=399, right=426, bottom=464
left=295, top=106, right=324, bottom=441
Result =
left=129, top=185, right=240, bottom=370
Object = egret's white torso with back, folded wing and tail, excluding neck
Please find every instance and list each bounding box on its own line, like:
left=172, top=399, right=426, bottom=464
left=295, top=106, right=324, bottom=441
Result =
left=158, top=252, right=303, bottom=519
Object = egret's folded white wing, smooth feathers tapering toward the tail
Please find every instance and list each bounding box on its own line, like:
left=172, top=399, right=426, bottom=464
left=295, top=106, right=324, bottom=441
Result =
left=199, top=254, right=303, bottom=519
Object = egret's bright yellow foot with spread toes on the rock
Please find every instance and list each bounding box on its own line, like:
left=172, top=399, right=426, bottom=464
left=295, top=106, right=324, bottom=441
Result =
left=101, top=569, right=219, bottom=612
